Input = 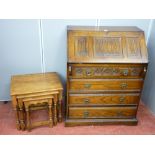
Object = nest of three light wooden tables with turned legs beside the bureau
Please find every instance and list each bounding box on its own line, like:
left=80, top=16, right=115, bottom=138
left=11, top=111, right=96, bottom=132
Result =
left=11, top=72, right=63, bottom=130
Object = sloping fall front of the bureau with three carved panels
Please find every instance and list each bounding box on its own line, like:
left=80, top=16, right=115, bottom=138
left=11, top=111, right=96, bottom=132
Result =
left=67, top=27, right=148, bottom=64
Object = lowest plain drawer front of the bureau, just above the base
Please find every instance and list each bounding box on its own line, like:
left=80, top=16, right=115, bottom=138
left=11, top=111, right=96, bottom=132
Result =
left=69, top=106, right=137, bottom=119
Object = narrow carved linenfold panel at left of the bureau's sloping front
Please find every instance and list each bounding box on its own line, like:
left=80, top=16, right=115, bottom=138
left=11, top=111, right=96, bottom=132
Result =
left=74, top=36, right=88, bottom=57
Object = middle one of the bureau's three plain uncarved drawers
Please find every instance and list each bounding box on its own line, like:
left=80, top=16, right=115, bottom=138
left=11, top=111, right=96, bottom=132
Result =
left=69, top=93, right=140, bottom=106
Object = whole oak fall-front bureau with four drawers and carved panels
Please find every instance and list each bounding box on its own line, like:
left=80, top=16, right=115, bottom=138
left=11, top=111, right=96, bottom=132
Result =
left=65, top=26, right=148, bottom=126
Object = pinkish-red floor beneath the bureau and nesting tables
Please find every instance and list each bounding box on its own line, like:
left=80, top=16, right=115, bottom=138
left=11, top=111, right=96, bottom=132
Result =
left=0, top=102, right=155, bottom=135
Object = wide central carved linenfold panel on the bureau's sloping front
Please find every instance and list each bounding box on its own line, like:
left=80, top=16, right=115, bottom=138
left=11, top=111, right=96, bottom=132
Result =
left=94, top=37, right=123, bottom=57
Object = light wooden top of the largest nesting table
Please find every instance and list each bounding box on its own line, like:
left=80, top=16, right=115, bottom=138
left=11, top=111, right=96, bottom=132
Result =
left=11, top=72, right=63, bottom=95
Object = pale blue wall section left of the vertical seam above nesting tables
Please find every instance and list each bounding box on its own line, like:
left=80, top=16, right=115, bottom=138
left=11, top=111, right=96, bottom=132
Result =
left=0, top=20, right=41, bottom=100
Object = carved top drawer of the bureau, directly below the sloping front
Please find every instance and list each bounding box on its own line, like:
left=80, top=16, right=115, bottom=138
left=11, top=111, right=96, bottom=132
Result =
left=68, top=64, right=146, bottom=78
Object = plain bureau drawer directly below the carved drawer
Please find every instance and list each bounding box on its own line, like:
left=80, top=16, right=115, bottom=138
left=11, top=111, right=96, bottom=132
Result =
left=69, top=79, right=143, bottom=92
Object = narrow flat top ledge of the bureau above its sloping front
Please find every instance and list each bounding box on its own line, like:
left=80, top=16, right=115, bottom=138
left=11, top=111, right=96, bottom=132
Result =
left=67, top=26, right=142, bottom=32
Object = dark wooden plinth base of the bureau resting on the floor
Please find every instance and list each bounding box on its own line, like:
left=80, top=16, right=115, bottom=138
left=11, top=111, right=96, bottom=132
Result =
left=65, top=118, right=138, bottom=127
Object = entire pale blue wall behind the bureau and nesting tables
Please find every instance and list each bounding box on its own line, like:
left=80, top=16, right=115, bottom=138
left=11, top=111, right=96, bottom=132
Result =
left=0, top=19, right=155, bottom=112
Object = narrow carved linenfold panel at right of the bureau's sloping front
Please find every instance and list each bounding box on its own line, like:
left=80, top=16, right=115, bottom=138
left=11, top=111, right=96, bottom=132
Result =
left=126, top=37, right=141, bottom=58
